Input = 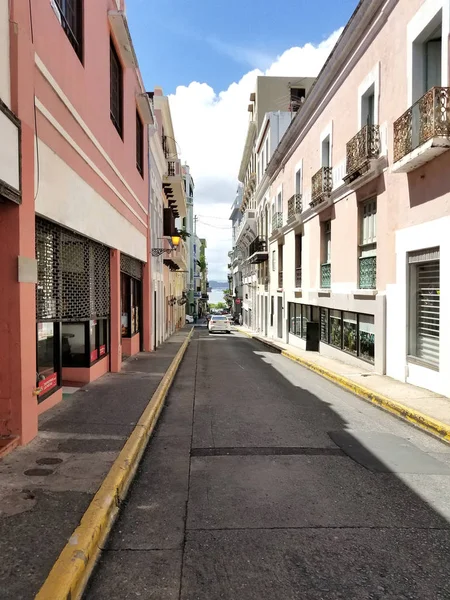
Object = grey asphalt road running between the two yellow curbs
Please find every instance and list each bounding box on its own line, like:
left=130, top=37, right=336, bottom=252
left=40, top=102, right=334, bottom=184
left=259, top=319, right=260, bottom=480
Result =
left=85, top=328, right=450, bottom=600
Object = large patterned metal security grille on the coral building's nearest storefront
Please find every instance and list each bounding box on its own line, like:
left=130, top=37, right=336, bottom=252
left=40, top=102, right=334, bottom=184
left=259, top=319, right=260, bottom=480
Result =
left=36, top=218, right=110, bottom=321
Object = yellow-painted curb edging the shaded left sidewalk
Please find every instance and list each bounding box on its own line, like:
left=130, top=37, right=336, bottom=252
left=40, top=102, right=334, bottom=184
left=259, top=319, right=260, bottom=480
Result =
left=35, top=328, right=194, bottom=600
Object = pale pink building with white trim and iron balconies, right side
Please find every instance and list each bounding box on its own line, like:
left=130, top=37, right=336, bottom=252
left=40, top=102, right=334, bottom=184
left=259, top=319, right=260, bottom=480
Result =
left=243, top=0, right=450, bottom=396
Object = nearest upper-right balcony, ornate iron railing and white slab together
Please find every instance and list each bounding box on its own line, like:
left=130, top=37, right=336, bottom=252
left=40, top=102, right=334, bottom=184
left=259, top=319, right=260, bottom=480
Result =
left=392, top=87, right=450, bottom=173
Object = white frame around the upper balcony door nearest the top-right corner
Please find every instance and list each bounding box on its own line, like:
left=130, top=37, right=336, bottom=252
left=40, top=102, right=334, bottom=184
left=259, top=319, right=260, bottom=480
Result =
left=406, top=0, right=450, bottom=107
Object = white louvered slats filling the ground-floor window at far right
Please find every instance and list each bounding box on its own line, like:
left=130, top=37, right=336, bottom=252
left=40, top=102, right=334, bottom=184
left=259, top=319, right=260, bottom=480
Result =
left=416, top=260, right=440, bottom=366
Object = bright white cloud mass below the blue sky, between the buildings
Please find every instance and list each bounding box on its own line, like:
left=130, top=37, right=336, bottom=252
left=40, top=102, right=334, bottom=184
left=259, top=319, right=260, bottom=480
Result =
left=170, top=29, right=342, bottom=281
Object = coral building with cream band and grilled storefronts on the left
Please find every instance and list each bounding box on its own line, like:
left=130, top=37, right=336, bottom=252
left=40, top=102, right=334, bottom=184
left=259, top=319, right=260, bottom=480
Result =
left=0, top=0, right=153, bottom=450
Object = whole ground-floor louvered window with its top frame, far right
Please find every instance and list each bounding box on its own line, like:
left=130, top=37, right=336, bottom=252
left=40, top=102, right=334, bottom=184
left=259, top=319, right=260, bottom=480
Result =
left=408, top=248, right=440, bottom=368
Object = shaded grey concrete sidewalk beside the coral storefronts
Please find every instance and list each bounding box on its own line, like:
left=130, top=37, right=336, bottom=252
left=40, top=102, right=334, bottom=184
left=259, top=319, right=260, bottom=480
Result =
left=0, top=327, right=191, bottom=600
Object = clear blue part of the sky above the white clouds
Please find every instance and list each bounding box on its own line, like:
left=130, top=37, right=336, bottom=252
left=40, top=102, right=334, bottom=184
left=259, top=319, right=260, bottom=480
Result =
left=127, top=0, right=357, bottom=94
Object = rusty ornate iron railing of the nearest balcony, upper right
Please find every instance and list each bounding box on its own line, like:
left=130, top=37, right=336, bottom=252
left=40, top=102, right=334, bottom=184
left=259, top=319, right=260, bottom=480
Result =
left=394, top=87, right=450, bottom=162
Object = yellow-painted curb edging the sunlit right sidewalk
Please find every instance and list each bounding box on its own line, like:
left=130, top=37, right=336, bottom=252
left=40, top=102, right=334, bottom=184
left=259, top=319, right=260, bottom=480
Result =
left=238, top=329, right=450, bottom=444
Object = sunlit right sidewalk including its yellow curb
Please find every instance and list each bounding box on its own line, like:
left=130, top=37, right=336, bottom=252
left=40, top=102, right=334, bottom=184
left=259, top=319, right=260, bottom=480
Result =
left=236, top=327, right=450, bottom=442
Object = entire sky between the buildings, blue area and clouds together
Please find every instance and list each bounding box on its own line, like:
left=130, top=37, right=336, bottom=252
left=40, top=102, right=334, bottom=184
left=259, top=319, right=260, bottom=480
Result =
left=127, top=0, right=358, bottom=281
